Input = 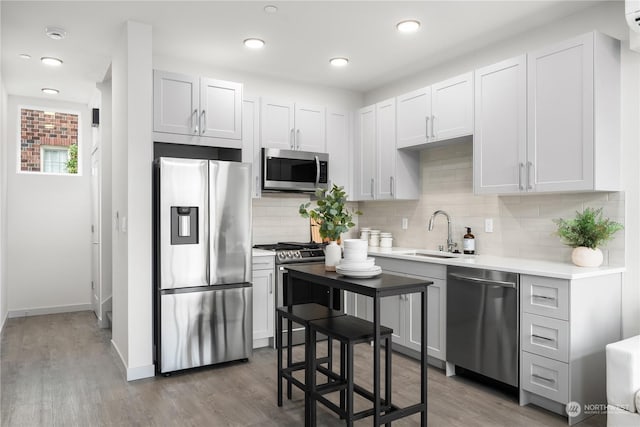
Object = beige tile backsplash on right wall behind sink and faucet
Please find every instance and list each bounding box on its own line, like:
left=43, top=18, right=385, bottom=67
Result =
left=358, top=141, right=625, bottom=265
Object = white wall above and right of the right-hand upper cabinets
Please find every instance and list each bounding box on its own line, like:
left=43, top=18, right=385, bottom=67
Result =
left=365, top=2, right=640, bottom=336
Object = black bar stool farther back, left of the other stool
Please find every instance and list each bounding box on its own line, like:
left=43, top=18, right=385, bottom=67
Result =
left=276, top=303, right=344, bottom=406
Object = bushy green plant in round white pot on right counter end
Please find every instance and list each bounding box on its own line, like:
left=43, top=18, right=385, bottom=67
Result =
left=554, top=208, right=623, bottom=267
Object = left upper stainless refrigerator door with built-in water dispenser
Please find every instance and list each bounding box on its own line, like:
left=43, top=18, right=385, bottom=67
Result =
left=159, top=157, right=209, bottom=289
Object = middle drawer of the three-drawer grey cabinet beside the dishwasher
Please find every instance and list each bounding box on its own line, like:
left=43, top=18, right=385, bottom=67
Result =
left=520, top=313, right=569, bottom=363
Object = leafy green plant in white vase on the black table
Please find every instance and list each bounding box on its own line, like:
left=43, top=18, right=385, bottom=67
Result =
left=298, top=184, right=361, bottom=271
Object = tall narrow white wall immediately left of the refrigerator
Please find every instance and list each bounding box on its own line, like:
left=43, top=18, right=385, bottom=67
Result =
left=112, top=22, right=154, bottom=380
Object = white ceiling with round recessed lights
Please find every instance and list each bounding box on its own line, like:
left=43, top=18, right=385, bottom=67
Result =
left=0, top=0, right=608, bottom=103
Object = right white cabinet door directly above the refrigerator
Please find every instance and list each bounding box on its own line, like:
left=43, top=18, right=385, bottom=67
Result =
left=200, top=78, right=242, bottom=141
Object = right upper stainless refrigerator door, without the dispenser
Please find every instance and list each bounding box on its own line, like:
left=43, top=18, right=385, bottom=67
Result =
left=209, top=160, right=251, bottom=285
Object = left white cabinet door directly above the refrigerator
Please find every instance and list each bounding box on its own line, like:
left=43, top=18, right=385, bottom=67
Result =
left=153, top=70, right=200, bottom=135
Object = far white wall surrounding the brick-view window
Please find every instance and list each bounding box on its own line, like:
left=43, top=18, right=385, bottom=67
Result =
left=5, top=96, right=91, bottom=317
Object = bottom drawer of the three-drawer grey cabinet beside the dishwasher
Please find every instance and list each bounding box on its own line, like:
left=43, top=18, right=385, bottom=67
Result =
left=520, top=351, right=569, bottom=403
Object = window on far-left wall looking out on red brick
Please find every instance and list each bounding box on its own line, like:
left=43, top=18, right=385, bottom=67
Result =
left=18, top=108, right=79, bottom=175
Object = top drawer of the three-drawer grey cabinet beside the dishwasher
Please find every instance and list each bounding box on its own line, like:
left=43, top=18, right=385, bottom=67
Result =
left=520, top=275, right=569, bottom=320
